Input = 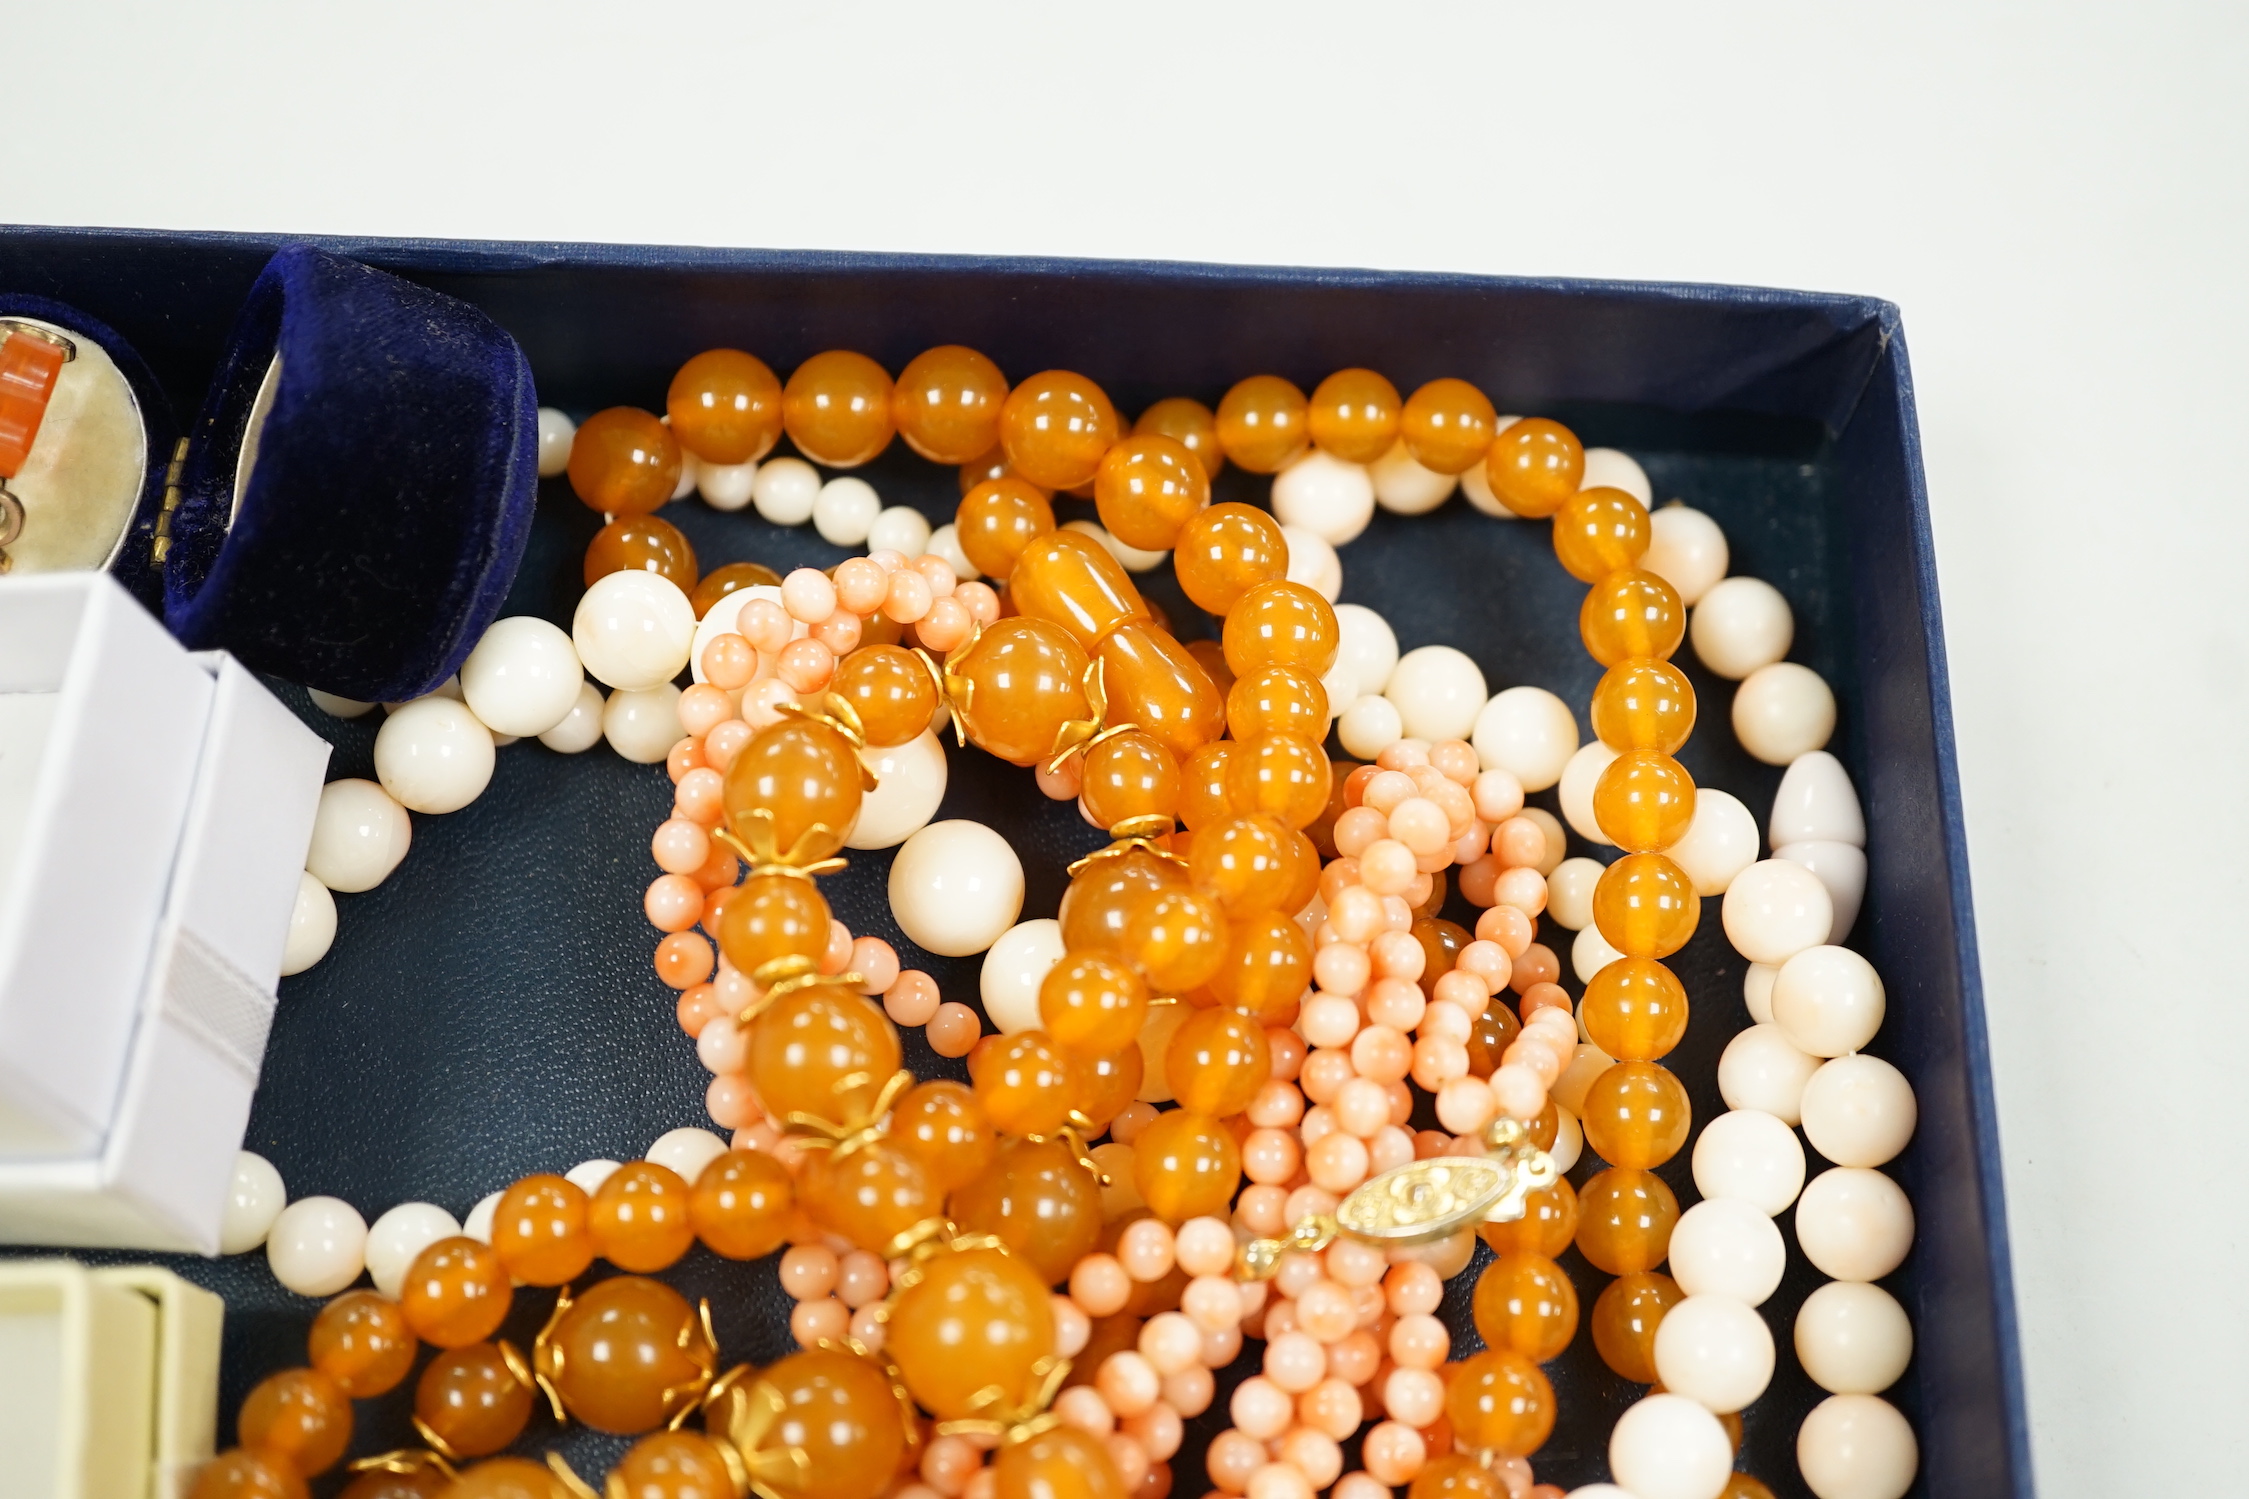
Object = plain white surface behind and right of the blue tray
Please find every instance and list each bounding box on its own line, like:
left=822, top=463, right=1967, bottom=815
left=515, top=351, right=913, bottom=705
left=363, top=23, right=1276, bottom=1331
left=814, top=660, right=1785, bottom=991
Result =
left=0, top=0, right=2249, bottom=1497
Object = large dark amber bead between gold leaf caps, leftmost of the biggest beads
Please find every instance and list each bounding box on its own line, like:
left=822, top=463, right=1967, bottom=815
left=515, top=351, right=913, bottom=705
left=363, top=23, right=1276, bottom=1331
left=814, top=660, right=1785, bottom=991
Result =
left=542, top=1274, right=717, bottom=1436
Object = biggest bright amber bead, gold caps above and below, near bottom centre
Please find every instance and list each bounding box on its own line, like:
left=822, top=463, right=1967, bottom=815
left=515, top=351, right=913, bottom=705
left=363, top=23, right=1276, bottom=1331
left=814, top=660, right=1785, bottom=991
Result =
left=884, top=1250, right=1062, bottom=1420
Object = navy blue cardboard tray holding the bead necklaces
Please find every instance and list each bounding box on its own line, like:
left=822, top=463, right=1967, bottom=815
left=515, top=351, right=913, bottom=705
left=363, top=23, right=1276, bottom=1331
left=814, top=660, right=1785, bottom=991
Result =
left=0, top=229, right=2031, bottom=1499
